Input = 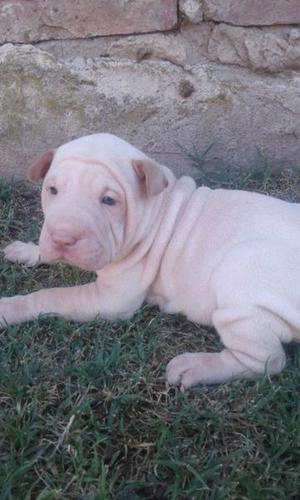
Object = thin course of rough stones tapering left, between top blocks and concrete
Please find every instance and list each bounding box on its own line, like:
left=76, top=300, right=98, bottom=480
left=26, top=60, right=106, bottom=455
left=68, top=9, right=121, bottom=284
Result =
left=43, top=22, right=300, bottom=73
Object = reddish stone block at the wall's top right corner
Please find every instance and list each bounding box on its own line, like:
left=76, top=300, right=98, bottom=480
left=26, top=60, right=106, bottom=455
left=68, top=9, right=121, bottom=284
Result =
left=203, top=0, right=300, bottom=26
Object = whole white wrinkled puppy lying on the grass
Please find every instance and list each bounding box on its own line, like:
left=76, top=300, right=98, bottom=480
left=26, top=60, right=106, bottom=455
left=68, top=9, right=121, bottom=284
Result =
left=0, top=134, right=300, bottom=389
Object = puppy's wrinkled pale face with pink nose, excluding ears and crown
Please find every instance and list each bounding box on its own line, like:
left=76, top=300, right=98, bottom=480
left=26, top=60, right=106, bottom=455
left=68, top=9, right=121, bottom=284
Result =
left=39, top=161, right=126, bottom=271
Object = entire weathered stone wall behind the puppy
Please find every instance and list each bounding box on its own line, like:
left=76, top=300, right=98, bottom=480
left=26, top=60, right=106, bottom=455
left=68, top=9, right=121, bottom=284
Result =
left=0, top=0, right=300, bottom=176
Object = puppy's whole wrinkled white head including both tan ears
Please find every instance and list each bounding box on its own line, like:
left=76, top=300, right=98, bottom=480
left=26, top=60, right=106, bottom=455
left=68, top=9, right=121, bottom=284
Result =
left=29, top=134, right=173, bottom=271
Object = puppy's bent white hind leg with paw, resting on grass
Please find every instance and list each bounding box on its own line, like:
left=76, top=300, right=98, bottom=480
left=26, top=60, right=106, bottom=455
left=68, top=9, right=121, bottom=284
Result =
left=166, top=308, right=288, bottom=390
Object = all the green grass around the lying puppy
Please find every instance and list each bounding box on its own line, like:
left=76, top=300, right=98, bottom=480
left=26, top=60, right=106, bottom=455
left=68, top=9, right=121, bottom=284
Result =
left=0, top=161, right=300, bottom=500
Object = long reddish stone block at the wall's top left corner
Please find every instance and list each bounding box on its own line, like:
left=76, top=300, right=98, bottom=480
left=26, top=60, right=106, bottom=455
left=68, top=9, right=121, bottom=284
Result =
left=0, top=0, right=177, bottom=43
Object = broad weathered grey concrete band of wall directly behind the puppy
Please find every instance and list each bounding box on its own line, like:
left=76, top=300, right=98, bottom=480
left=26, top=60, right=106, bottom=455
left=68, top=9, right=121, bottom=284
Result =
left=0, top=44, right=300, bottom=180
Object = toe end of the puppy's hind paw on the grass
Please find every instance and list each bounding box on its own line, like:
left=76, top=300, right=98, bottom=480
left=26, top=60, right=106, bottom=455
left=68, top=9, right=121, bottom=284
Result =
left=166, top=352, right=205, bottom=392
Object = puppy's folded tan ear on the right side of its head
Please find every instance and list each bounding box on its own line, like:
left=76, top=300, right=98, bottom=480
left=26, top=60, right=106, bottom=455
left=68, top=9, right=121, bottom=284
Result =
left=132, top=159, right=168, bottom=196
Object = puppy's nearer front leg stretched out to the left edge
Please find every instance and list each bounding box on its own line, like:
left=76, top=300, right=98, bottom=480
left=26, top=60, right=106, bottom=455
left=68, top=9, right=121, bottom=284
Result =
left=0, top=282, right=116, bottom=327
